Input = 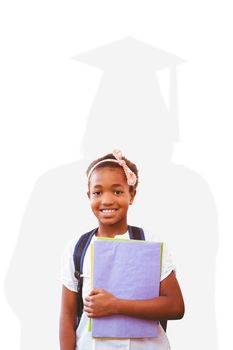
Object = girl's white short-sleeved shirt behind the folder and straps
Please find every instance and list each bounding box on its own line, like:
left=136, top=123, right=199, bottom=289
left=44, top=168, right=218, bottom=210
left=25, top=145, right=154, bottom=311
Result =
left=61, top=232, right=174, bottom=350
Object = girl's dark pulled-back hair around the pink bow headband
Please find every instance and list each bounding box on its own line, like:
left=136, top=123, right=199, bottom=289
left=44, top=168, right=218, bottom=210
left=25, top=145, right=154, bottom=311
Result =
left=86, top=153, right=138, bottom=190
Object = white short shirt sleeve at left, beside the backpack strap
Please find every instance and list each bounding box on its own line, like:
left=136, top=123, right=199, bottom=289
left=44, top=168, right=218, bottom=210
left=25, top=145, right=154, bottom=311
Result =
left=60, top=239, right=78, bottom=292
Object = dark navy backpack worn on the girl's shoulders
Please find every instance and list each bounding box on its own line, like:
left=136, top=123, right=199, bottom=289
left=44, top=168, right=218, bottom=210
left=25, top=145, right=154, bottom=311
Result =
left=73, top=226, right=167, bottom=332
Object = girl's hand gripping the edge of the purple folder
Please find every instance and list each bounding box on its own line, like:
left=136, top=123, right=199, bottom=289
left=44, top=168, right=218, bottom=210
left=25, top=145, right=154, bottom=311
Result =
left=83, top=289, right=117, bottom=318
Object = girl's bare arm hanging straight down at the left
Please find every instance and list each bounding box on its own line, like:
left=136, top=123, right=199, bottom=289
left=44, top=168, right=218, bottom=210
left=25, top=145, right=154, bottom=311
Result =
left=59, top=286, right=78, bottom=350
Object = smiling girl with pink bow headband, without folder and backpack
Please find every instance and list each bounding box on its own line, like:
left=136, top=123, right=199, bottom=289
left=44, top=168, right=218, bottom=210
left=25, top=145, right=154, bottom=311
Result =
left=60, top=151, right=184, bottom=350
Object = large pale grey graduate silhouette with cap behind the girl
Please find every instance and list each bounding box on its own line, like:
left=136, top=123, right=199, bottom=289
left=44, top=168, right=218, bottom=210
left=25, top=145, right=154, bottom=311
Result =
left=5, top=38, right=218, bottom=350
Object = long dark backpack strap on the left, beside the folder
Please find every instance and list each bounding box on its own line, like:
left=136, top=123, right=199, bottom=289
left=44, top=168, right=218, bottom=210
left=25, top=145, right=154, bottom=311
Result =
left=73, top=228, right=98, bottom=326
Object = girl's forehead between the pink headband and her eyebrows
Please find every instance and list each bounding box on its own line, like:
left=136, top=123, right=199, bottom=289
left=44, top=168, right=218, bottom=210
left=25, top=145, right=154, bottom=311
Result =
left=90, top=167, right=128, bottom=186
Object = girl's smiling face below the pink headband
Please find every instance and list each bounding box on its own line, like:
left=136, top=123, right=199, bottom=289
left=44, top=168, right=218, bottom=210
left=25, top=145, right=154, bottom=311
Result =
left=88, top=167, right=136, bottom=229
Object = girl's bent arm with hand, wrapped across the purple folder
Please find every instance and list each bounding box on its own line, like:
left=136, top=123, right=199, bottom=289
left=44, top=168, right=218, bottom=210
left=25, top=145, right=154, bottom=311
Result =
left=84, top=272, right=184, bottom=320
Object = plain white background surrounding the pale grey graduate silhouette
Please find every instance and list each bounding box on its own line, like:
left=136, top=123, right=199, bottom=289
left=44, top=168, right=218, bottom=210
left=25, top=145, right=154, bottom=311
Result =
left=0, top=0, right=233, bottom=350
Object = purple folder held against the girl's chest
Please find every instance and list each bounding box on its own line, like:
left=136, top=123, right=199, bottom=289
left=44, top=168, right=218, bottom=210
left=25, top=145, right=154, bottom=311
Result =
left=92, top=239, right=161, bottom=338
